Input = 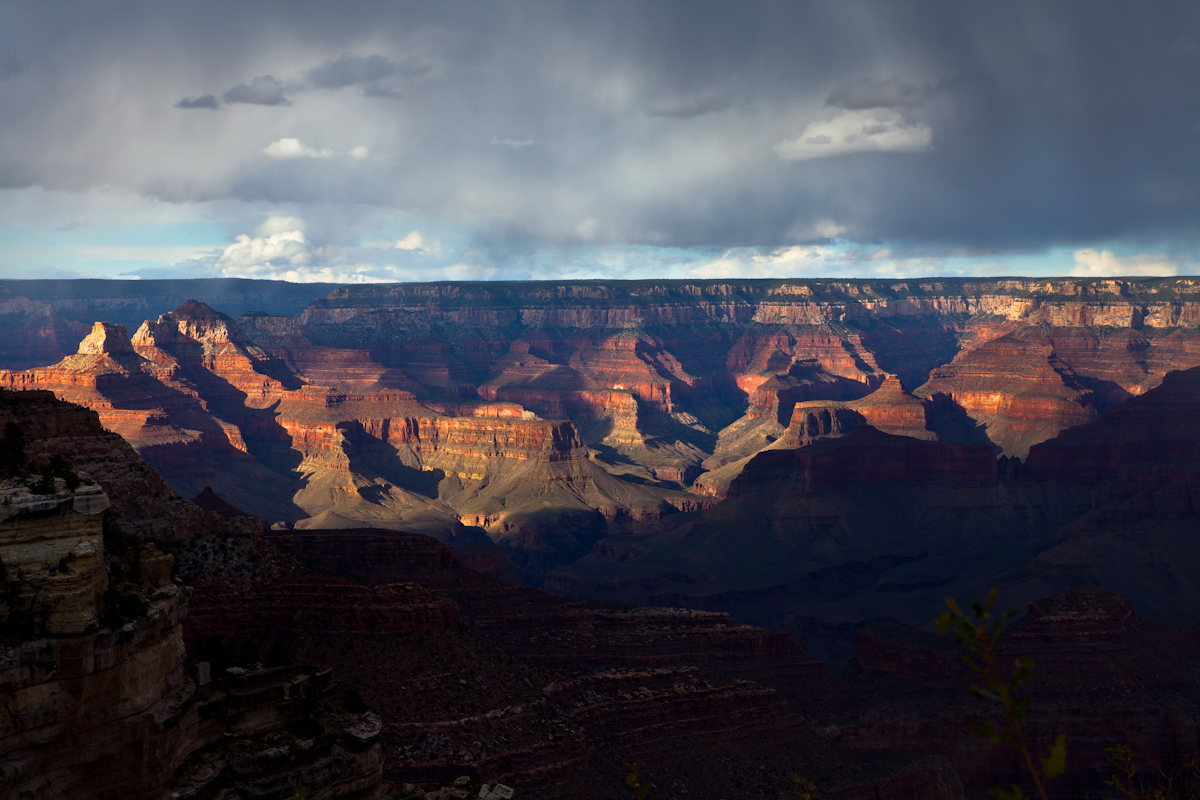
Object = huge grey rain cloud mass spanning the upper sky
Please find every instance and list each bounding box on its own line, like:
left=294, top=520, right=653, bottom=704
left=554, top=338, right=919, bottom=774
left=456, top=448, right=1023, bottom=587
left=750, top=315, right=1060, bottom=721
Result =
left=0, top=0, right=1200, bottom=258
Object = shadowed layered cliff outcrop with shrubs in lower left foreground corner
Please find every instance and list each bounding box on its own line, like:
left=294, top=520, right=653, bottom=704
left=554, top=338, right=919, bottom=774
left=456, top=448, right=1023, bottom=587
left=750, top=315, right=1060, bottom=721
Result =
left=0, top=393, right=390, bottom=800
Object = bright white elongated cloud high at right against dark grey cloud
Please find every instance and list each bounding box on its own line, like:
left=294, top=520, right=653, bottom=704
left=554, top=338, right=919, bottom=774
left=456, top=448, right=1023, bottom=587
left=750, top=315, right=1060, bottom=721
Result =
left=775, top=108, right=934, bottom=161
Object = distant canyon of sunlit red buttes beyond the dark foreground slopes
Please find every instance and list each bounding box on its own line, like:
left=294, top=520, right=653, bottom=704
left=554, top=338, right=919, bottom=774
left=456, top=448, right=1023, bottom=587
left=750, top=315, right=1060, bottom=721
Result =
left=7, top=278, right=1200, bottom=662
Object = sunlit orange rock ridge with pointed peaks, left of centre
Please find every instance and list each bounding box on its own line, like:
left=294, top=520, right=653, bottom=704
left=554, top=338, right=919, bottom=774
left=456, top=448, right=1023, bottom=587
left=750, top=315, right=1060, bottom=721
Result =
left=0, top=302, right=695, bottom=579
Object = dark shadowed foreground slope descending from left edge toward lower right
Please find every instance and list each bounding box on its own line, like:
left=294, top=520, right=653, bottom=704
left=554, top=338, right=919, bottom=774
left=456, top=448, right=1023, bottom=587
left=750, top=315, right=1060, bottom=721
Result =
left=0, top=391, right=961, bottom=800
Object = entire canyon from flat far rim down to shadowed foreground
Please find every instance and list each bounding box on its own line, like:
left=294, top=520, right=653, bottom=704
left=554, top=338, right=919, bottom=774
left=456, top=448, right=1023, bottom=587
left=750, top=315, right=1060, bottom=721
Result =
left=7, top=273, right=1200, bottom=800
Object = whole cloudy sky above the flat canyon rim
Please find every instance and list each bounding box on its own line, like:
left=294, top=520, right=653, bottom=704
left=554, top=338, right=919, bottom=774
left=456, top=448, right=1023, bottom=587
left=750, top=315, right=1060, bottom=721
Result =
left=0, top=0, right=1200, bottom=282
